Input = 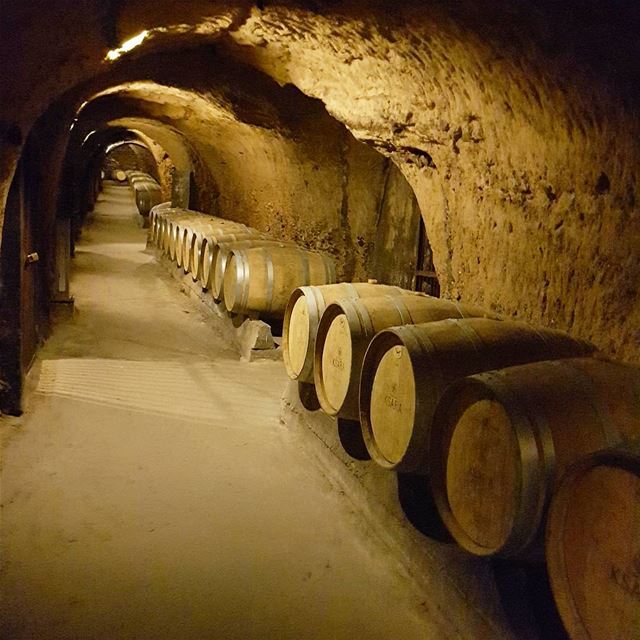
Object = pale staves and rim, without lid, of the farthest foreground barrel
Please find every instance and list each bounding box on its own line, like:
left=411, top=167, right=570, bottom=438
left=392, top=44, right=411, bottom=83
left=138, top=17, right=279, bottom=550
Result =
left=282, top=282, right=404, bottom=384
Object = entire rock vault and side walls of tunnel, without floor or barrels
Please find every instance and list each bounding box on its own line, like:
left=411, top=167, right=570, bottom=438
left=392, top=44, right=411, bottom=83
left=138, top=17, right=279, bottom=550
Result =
left=0, top=0, right=640, bottom=640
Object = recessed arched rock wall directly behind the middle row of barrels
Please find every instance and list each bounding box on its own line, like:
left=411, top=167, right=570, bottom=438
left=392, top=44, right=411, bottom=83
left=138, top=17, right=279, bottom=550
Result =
left=67, top=50, right=418, bottom=286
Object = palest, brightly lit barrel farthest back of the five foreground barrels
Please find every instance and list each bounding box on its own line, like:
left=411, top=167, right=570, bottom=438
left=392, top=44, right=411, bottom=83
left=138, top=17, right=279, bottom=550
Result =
left=282, top=282, right=409, bottom=383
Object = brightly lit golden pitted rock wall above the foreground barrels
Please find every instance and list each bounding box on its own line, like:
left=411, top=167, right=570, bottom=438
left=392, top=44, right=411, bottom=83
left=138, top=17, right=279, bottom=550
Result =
left=218, top=3, right=640, bottom=361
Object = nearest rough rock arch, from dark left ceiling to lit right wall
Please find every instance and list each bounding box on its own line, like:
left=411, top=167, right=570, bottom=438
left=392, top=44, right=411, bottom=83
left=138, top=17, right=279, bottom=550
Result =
left=0, top=0, right=640, bottom=372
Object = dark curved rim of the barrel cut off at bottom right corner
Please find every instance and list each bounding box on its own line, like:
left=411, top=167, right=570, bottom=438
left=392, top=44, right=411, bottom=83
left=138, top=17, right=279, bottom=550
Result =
left=545, top=439, right=640, bottom=640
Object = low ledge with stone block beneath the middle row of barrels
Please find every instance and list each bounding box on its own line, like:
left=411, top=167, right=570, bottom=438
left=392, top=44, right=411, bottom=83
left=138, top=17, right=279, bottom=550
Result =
left=151, top=248, right=282, bottom=361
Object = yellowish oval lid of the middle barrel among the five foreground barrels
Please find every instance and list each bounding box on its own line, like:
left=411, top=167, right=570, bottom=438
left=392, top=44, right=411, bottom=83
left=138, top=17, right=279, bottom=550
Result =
left=368, top=345, right=416, bottom=464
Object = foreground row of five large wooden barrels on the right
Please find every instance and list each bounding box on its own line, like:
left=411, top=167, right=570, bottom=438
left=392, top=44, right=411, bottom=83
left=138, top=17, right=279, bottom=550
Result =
left=283, top=283, right=640, bottom=640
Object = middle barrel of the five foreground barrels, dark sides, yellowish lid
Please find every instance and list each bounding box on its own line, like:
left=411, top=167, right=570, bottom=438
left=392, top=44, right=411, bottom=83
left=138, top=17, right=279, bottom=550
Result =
left=360, top=318, right=595, bottom=473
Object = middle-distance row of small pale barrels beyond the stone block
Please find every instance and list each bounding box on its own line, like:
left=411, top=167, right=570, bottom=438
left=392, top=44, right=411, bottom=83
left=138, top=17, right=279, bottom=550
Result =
left=150, top=203, right=335, bottom=318
